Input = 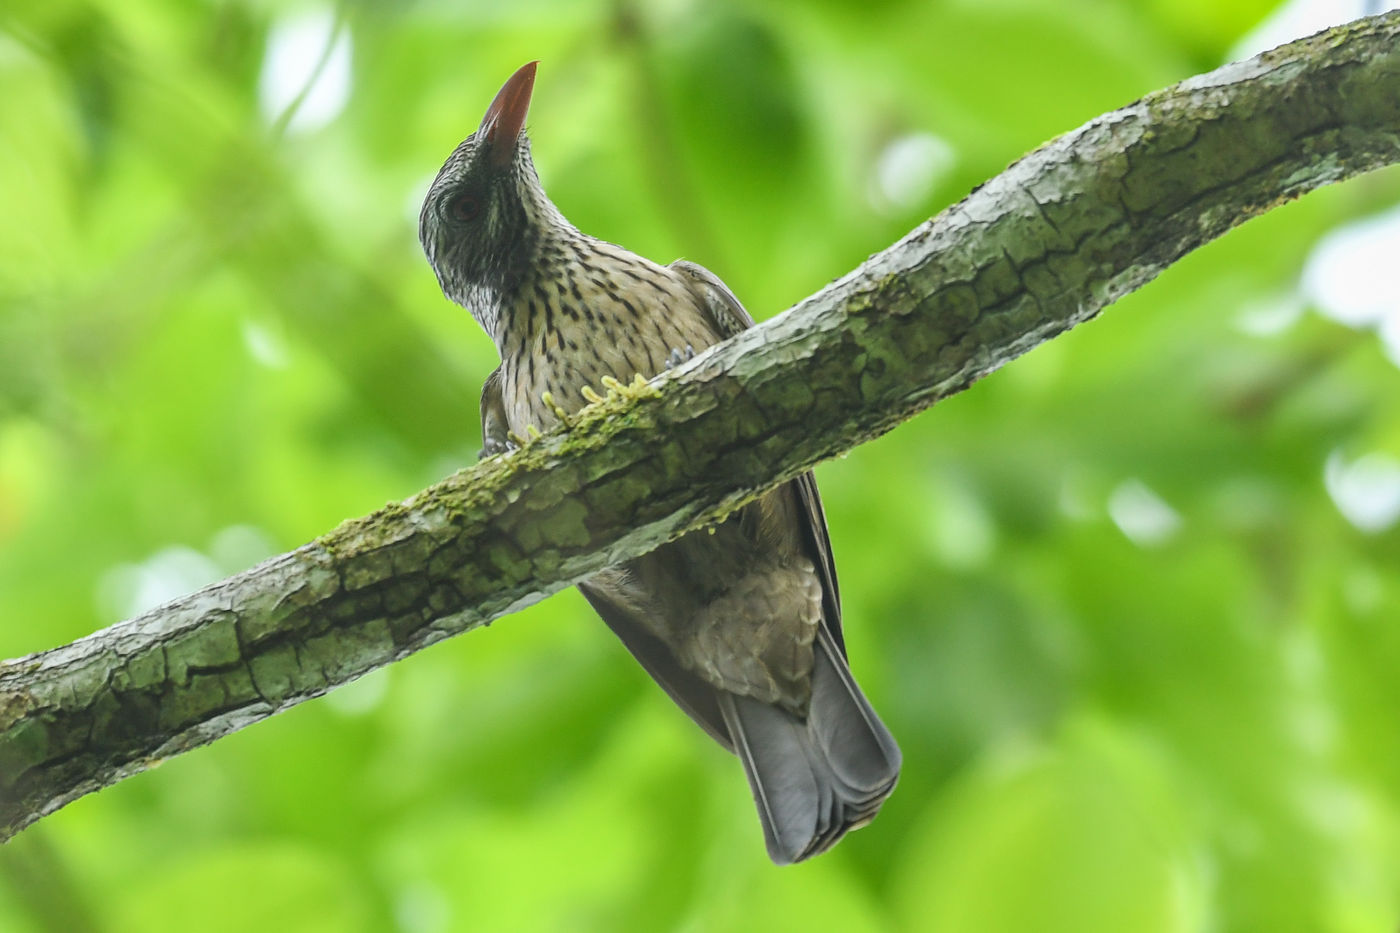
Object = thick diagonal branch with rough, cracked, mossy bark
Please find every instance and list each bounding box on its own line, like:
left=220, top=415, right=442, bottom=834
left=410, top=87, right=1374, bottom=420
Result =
left=0, top=14, right=1400, bottom=839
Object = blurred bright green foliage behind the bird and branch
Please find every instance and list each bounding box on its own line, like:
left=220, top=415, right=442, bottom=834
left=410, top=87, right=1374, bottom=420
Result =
left=0, top=0, right=1400, bottom=933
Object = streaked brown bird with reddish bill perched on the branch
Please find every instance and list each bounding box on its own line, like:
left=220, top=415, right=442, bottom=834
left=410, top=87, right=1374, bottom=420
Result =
left=419, top=62, right=902, bottom=864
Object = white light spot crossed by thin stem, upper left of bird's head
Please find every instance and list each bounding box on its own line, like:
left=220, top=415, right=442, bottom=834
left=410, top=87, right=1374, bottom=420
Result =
left=258, top=7, right=350, bottom=133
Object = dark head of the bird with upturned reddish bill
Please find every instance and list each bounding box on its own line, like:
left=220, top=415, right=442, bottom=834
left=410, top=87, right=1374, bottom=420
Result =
left=419, top=62, right=561, bottom=318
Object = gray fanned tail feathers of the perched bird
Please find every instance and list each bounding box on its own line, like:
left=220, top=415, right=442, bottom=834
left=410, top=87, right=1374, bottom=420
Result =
left=720, top=629, right=900, bottom=864
